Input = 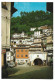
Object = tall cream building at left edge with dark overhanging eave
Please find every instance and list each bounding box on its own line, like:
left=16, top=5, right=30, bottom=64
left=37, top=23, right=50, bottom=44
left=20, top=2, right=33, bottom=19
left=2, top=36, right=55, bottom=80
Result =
left=1, top=2, right=16, bottom=66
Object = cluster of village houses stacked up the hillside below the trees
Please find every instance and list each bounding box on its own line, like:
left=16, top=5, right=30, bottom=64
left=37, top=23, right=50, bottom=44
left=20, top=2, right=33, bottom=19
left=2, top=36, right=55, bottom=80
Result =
left=6, top=25, right=53, bottom=66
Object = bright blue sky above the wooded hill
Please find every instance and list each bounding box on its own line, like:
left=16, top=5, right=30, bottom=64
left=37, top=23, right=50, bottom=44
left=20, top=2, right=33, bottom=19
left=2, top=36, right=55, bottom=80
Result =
left=12, top=2, right=46, bottom=17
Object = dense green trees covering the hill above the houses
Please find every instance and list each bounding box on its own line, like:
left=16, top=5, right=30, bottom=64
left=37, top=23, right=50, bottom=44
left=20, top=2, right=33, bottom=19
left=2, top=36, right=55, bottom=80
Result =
left=11, top=11, right=53, bottom=35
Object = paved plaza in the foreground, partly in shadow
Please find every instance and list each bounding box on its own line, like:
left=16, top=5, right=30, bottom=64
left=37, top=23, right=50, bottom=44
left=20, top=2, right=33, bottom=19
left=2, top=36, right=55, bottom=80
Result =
left=7, top=65, right=53, bottom=79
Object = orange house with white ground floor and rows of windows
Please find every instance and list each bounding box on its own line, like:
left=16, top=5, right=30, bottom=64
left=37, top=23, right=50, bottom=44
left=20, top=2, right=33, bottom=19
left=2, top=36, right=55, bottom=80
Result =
left=14, top=44, right=29, bottom=64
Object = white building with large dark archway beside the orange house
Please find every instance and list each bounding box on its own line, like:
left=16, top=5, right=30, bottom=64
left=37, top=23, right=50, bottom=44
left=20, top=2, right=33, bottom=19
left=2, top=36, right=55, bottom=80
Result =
left=29, top=51, right=47, bottom=65
